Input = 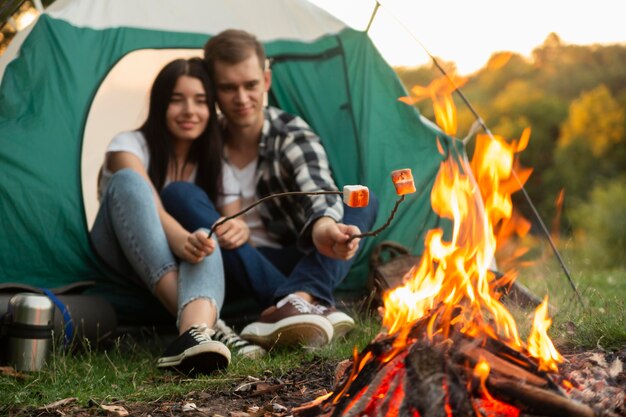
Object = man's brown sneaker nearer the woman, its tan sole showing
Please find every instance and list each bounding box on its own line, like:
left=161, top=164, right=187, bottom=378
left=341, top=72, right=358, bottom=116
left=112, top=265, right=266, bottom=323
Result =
left=241, top=294, right=333, bottom=349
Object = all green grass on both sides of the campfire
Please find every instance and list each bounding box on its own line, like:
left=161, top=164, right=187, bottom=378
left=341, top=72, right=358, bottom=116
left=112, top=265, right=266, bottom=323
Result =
left=0, top=245, right=626, bottom=415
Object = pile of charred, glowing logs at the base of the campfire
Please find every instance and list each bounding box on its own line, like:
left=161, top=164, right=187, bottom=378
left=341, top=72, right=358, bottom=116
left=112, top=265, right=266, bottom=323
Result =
left=292, top=328, right=595, bottom=417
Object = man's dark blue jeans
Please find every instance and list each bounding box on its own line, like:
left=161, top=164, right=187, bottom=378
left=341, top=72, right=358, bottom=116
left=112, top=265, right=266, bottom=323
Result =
left=161, top=182, right=378, bottom=306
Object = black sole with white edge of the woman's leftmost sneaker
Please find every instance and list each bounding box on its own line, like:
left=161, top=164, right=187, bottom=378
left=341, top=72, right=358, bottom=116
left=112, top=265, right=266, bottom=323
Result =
left=157, top=342, right=230, bottom=375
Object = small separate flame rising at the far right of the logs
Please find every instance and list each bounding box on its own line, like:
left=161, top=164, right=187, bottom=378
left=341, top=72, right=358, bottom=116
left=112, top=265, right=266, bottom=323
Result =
left=528, top=296, right=563, bottom=372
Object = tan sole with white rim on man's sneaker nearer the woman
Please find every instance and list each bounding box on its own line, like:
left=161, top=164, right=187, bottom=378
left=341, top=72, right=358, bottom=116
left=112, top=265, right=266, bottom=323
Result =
left=241, top=314, right=334, bottom=349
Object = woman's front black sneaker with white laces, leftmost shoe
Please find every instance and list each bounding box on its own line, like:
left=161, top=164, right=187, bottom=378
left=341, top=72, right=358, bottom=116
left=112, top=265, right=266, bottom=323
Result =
left=157, top=324, right=230, bottom=375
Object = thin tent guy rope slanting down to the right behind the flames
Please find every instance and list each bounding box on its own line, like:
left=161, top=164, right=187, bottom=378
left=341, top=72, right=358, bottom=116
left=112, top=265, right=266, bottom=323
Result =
left=367, top=0, right=585, bottom=308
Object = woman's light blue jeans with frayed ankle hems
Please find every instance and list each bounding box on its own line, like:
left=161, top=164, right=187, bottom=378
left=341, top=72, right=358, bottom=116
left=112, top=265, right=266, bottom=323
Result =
left=91, top=169, right=225, bottom=324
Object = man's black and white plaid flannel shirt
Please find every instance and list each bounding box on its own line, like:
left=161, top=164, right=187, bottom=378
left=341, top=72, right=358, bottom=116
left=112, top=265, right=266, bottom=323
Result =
left=249, top=107, right=343, bottom=251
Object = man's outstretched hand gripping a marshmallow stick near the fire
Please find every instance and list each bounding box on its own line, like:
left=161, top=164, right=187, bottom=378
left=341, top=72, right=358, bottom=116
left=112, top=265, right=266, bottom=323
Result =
left=312, top=217, right=361, bottom=260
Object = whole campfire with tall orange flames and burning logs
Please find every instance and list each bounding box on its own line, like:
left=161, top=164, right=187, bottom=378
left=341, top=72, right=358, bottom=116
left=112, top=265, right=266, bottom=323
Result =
left=294, top=76, right=594, bottom=417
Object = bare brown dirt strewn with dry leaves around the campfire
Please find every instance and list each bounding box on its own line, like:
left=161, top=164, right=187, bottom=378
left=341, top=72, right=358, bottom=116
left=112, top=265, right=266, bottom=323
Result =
left=12, top=349, right=626, bottom=417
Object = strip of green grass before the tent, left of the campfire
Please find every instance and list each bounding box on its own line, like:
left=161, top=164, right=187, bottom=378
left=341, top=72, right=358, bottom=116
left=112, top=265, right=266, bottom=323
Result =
left=0, top=308, right=379, bottom=415
